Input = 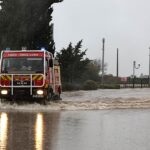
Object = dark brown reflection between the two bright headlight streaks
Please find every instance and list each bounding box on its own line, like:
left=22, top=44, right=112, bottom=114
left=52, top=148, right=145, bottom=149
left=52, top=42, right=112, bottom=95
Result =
left=7, top=112, right=36, bottom=150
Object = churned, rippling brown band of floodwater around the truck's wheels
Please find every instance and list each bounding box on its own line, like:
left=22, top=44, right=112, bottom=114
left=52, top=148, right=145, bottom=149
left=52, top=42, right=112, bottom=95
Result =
left=0, top=89, right=150, bottom=112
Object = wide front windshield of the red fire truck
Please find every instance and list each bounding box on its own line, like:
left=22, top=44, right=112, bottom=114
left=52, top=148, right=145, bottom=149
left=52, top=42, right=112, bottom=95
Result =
left=2, top=57, right=44, bottom=73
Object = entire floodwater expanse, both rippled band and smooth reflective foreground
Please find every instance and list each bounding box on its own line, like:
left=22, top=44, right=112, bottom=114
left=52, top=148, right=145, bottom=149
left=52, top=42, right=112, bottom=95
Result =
left=0, top=89, right=150, bottom=150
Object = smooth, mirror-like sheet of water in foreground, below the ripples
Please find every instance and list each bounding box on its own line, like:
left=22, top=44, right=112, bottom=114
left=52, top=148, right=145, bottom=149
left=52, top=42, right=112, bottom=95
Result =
left=0, top=109, right=150, bottom=150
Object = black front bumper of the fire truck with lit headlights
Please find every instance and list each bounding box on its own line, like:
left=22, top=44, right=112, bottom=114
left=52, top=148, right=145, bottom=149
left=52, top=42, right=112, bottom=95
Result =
left=0, top=88, right=46, bottom=99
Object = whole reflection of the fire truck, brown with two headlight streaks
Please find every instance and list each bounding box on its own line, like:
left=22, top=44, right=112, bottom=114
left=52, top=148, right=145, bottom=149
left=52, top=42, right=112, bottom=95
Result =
left=0, top=112, right=60, bottom=150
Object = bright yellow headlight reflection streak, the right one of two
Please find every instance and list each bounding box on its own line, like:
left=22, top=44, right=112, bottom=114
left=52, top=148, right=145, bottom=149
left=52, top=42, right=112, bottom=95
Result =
left=35, top=113, right=43, bottom=150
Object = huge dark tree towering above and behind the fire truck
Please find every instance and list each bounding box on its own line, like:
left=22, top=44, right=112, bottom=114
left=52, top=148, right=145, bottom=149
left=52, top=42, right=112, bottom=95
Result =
left=0, top=0, right=62, bottom=54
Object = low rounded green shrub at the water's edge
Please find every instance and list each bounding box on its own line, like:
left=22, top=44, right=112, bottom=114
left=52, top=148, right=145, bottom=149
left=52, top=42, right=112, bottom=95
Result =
left=83, top=80, right=98, bottom=90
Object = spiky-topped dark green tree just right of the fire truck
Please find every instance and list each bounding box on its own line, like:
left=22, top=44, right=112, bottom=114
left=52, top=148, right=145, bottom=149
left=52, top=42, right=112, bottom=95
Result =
left=57, top=40, right=90, bottom=83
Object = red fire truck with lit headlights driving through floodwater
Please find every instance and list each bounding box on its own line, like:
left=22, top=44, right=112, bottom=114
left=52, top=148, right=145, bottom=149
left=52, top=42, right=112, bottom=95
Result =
left=0, top=50, right=61, bottom=103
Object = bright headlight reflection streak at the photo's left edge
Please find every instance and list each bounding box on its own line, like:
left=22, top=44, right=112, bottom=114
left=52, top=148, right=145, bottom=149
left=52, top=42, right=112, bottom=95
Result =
left=0, top=113, right=8, bottom=150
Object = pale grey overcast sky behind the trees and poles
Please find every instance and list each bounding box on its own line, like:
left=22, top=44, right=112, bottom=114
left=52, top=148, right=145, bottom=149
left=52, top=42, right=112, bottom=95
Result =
left=53, top=0, right=150, bottom=77
